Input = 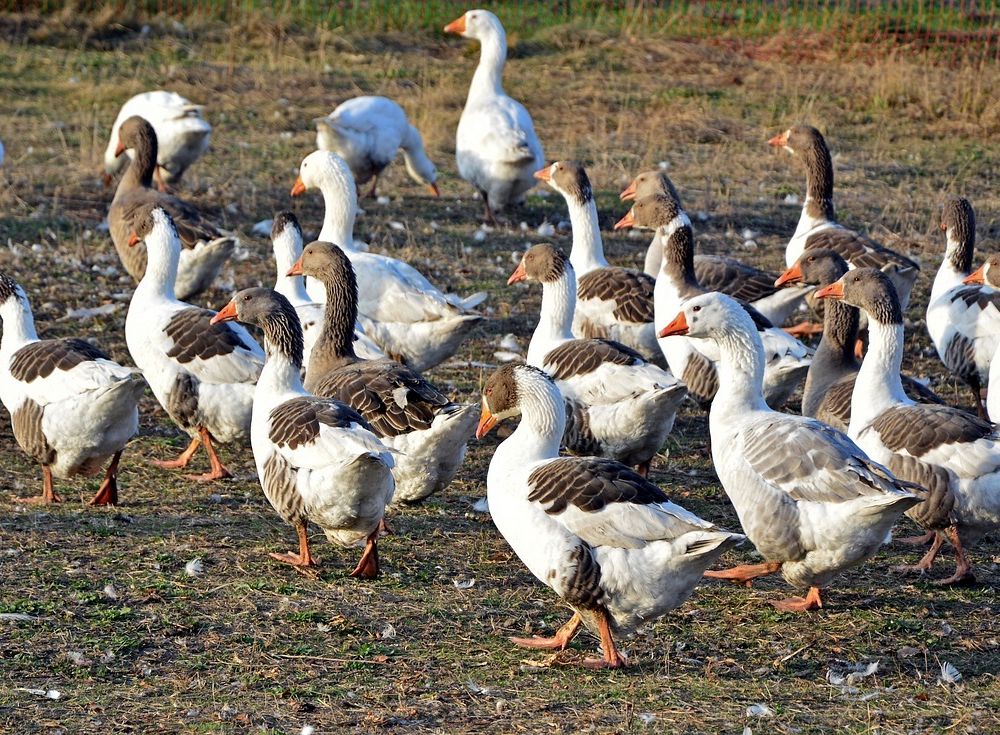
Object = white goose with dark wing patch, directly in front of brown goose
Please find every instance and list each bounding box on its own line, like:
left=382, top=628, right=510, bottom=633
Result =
left=125, top=206, right=264, bottom=481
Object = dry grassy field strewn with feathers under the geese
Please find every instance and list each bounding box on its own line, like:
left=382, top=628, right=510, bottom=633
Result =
left=0, top=11, right=1000, bottom=735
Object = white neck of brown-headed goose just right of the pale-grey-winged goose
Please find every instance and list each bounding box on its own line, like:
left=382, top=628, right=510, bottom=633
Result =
left=848, top=314, right=914, bottom=437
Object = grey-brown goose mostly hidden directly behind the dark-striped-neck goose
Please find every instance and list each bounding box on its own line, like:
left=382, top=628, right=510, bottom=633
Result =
left=620, top=170, right=811, bottom=328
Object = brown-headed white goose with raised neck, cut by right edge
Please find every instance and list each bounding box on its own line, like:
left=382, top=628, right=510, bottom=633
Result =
left=927, top=197, right=1000, bottom=418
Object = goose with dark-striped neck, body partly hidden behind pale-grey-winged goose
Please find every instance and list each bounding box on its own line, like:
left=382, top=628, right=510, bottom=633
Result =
left=615, top=197, right=810, bottom=406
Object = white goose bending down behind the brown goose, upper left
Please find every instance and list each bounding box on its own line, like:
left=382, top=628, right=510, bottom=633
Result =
left=104, top=90, right=212, bottom=191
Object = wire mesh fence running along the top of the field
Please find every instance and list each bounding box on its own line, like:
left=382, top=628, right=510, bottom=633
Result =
left=7, top=0, right=1000, bottom=61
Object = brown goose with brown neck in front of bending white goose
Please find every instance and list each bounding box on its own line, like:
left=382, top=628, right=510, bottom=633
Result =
left=108, top=116, right=236, bottom=300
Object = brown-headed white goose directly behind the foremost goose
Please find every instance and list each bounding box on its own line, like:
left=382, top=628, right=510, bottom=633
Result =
left=507, top=244, right=687, bottom=477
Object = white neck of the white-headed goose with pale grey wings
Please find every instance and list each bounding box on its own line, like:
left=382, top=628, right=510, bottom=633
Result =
left=711, top=324, right=770, bottom=421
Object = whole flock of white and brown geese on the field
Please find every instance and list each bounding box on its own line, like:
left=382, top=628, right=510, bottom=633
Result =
left=0, top=10, right=1000, bottom=667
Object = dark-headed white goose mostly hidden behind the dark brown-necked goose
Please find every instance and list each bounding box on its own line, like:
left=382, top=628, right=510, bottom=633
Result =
left=271, top=212, right=385, bottom=365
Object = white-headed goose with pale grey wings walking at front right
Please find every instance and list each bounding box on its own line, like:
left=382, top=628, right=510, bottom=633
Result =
left=660, top=292, right=922, bottom=611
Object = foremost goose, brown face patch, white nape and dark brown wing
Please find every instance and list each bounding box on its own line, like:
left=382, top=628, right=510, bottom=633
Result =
left=476, top=364, right=743, bottom=668
